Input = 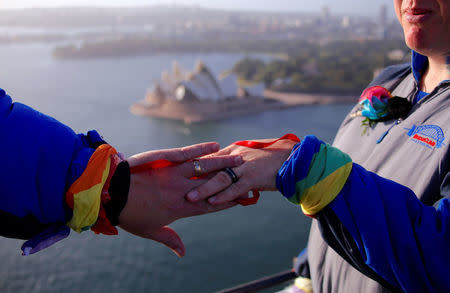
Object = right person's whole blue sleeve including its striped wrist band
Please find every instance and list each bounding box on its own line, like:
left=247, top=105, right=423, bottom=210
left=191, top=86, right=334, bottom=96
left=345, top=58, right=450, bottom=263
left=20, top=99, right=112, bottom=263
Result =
left=277, top=137, right=450, bottom=292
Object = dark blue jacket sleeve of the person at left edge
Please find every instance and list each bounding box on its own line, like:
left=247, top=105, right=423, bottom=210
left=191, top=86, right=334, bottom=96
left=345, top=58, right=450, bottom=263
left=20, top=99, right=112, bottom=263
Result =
left=0, top=89, right=103, bottom=239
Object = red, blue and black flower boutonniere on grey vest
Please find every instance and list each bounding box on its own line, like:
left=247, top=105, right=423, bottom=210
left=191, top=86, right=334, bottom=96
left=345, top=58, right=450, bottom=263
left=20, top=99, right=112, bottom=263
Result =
left=351, top=86, right=412, bottom=134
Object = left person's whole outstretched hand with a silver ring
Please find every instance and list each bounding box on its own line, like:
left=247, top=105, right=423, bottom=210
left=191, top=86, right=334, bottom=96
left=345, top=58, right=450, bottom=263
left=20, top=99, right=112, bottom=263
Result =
left=119, top=143, right=243, bottom=257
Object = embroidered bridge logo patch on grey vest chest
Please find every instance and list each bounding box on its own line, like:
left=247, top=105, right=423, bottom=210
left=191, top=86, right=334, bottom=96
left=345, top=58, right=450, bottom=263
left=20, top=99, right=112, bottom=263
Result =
left=405, top=125, right=445, bottom=149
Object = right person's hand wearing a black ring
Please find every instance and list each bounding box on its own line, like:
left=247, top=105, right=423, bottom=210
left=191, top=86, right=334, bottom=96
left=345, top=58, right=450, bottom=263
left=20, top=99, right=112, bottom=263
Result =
left=187, top=139, right=296, bottom=206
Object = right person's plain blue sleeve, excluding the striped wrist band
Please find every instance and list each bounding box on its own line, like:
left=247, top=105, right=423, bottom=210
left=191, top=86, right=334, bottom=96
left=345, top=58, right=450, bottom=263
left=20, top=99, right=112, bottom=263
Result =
left=317, top=164, right=450, bottom=292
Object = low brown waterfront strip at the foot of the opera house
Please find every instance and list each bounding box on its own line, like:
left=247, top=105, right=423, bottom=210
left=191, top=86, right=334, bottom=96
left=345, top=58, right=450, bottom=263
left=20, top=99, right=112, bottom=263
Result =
left=130, top=90, right=357, bottom=124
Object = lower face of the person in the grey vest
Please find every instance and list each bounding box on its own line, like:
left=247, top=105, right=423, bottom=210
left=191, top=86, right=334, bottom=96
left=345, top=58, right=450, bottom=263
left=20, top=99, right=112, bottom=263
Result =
left=394, top=0, right=450, bottom=56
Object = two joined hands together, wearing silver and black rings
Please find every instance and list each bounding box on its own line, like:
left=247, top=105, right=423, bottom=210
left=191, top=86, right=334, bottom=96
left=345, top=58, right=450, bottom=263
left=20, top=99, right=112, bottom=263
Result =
left=119, top=140, right=295, bottom=257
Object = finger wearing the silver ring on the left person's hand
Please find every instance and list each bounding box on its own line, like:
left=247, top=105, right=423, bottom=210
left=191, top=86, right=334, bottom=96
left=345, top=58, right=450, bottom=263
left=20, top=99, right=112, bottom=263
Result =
left=180, top=155, right=244, bottom=178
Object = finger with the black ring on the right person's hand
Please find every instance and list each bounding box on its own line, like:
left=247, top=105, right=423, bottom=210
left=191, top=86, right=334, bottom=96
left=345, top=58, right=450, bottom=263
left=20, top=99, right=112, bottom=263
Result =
left=186, top=168, right=245, bottom=202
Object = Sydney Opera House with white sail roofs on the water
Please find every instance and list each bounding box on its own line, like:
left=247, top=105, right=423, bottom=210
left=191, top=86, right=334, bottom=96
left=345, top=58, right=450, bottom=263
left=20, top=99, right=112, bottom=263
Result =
left=131, top=61, right=279, bottom=123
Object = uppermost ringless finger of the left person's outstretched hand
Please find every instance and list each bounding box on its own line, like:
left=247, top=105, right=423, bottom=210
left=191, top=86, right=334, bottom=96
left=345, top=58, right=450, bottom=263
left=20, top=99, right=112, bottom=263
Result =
left=127, top=142, right=220, bottom=167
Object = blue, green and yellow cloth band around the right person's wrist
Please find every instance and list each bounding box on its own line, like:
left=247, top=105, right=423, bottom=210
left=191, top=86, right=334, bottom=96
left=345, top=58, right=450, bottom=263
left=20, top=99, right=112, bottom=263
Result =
left=277, top=136, right=352, bottom=216
